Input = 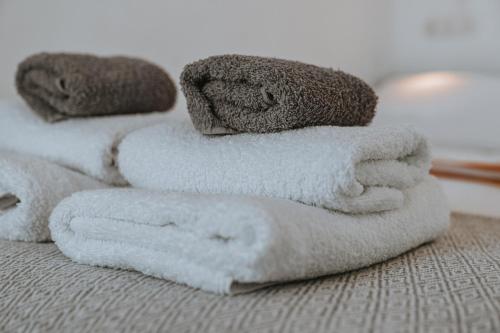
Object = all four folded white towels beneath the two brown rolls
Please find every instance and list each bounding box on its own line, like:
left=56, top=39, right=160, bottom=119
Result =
left=0, top=102, right=449, bottom=294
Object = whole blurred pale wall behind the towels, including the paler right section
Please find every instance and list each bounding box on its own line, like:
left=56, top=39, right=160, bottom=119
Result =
left=0, top=0, right=500, bottom=100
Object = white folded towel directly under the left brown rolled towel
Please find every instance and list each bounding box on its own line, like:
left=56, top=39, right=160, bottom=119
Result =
left=0, top=101, right=170, bottom=185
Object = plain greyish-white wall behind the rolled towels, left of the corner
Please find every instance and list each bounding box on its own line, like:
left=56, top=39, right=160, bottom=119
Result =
left=0, top=0, right=390, bottom=98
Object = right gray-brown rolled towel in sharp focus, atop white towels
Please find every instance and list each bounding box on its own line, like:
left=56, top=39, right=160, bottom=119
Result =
left=181, top=55, right=377, bottom=134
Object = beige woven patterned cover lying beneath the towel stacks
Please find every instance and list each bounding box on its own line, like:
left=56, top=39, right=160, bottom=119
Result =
left=0, top=214, right=500, bottom=333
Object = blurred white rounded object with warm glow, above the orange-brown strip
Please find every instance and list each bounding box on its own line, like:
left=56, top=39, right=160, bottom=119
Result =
left=374, top=72, right=500, bottom=154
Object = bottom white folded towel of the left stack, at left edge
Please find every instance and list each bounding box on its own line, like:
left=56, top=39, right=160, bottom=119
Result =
left=0, top=151, right=105, bottom=241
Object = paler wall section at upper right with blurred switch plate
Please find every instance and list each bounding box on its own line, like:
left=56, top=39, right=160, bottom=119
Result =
left=390, top=0, right=500, bottom=72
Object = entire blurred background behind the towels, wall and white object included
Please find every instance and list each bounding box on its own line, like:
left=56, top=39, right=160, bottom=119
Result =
left=0, top=0, right=500, bottom=215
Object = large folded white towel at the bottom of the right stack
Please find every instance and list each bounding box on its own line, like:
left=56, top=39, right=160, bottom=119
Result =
left=50, top=178, right=449, bottom=293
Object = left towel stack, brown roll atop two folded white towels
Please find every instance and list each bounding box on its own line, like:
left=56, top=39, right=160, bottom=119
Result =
left=0, top=53, right=176, bottom=241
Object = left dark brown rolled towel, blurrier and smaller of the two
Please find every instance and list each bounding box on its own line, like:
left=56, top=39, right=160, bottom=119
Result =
left=16, top=53, right=176, bottom=122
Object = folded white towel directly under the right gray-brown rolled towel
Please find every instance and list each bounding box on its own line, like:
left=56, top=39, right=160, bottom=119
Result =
left=118, top=121, right=430, bottom=213
